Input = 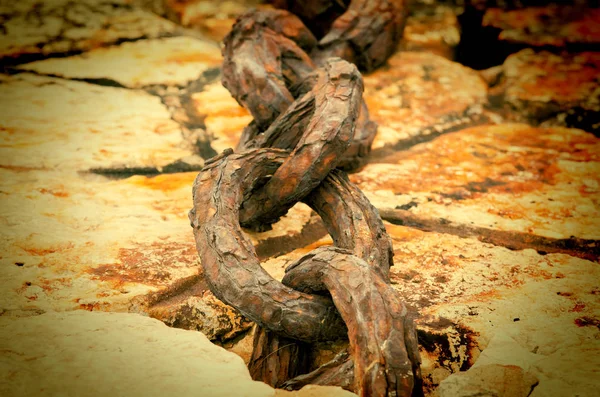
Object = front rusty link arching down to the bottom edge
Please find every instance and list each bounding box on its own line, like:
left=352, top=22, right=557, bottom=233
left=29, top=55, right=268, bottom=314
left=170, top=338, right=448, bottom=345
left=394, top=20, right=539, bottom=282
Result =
left=282, top=247, right=421, bottom=396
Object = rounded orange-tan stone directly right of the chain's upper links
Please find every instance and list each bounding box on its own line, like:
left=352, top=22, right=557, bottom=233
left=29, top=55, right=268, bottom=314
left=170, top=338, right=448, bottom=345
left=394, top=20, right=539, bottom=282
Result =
left=363, top=52, right=487, bottom=157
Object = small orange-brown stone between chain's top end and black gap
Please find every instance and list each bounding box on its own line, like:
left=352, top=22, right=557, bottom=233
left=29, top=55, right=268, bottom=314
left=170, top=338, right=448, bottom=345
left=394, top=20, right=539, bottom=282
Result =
left=400, top=5, right=460, bottom=60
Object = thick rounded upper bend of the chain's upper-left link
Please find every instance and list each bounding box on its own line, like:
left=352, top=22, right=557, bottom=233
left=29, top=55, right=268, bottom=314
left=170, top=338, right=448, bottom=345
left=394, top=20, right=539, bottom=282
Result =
left=222, top=10, right=316, bottom=131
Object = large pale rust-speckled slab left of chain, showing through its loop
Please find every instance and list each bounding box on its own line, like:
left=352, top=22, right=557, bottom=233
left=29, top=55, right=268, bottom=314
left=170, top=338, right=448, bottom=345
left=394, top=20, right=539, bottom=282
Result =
left=0, top=168, right=318, bottom=341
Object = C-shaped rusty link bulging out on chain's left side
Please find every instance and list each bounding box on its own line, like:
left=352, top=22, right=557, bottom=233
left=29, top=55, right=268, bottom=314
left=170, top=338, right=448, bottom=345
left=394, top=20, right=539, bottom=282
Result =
left=189, top=149, right=346, bottom=341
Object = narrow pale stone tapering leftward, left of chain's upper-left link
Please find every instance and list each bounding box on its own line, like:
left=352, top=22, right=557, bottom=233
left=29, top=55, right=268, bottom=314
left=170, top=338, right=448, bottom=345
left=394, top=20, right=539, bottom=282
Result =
left=20, top=36, right=222, bottom=88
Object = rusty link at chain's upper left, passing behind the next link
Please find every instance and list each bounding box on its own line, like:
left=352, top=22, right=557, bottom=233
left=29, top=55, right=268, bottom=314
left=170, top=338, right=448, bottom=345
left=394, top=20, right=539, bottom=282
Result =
left=222, top=10, right=377, bottom=170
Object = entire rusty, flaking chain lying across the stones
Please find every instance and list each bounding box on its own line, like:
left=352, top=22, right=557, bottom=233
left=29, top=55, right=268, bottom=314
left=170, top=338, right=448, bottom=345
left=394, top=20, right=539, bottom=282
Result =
left=190, top=0, right=423, bottom=396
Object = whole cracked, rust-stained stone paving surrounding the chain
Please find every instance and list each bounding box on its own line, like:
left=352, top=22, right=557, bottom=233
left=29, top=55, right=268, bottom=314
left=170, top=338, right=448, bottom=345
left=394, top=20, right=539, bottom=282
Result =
left=0, top=0, right=600, bottom=397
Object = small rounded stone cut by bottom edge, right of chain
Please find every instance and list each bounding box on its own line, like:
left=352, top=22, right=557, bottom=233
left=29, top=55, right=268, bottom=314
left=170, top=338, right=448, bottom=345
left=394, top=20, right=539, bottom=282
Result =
left=437, top=364, right=538, bottom=397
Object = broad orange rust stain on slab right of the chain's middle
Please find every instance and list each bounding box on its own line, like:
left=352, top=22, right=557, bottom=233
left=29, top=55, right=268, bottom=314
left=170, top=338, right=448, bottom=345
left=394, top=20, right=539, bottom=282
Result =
left=350, top=125, right=600, bottom=200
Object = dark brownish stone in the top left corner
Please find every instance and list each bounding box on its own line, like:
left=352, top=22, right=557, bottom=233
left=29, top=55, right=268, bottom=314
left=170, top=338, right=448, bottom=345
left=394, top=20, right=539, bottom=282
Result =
left=0, top=0, right=179, bottom=62
